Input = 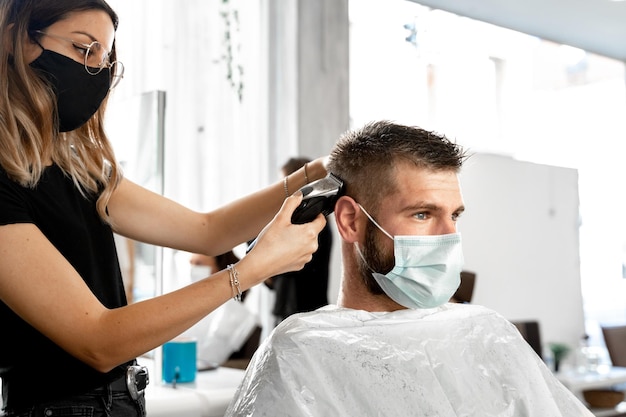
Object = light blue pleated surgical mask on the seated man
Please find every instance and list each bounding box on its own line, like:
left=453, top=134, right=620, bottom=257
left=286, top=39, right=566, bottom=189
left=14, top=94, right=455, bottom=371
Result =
left=357, top=204, right=464, bottom=308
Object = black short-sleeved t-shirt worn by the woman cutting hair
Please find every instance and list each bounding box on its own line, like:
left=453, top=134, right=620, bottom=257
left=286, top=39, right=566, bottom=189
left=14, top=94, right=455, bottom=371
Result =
left=0, top=165, right=126, bottom=409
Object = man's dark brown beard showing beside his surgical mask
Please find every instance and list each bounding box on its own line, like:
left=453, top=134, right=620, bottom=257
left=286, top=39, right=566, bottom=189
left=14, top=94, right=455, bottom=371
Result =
left=357, top=222, right=395, bottom=295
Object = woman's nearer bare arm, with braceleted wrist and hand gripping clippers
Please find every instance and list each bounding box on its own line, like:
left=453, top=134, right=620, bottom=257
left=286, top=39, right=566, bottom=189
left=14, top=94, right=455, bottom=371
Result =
left=0, top=195, right=325, bottom=372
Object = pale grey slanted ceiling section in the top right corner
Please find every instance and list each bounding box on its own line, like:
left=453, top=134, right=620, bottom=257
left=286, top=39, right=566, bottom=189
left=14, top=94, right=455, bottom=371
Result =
left=412, top=0, right=626, bottom=61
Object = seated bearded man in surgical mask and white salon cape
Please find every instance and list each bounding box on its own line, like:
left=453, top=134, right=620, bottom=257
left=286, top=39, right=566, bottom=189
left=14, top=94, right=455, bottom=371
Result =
left=226, top=122, right=592, bottom=417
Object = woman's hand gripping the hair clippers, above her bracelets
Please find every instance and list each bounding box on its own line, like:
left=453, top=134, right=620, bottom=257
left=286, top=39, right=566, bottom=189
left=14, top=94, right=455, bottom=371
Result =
left=238, top=192, right=326, bottom=285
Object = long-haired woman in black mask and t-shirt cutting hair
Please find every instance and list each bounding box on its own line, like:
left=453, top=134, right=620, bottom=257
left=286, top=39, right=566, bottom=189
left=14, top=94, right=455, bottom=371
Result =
left=0, top=0, right=326, bottom=417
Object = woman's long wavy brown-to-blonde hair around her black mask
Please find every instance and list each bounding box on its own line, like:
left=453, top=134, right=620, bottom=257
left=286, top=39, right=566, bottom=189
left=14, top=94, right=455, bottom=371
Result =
left=0, top=0, right=122, bottom=222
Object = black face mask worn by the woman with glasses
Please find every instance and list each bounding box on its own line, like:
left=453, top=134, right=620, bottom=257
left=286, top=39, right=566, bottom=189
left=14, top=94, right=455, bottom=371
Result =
left=30, top=49, right=111, bottom=132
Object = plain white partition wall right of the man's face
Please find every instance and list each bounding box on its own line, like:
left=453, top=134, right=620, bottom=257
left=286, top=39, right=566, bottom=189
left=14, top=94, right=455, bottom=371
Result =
left=459, top=154, right=584, bottom=352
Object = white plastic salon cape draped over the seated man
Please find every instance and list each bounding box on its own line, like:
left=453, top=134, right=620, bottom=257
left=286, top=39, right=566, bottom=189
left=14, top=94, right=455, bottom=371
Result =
left=226, top=304, right=593, bottom=417
